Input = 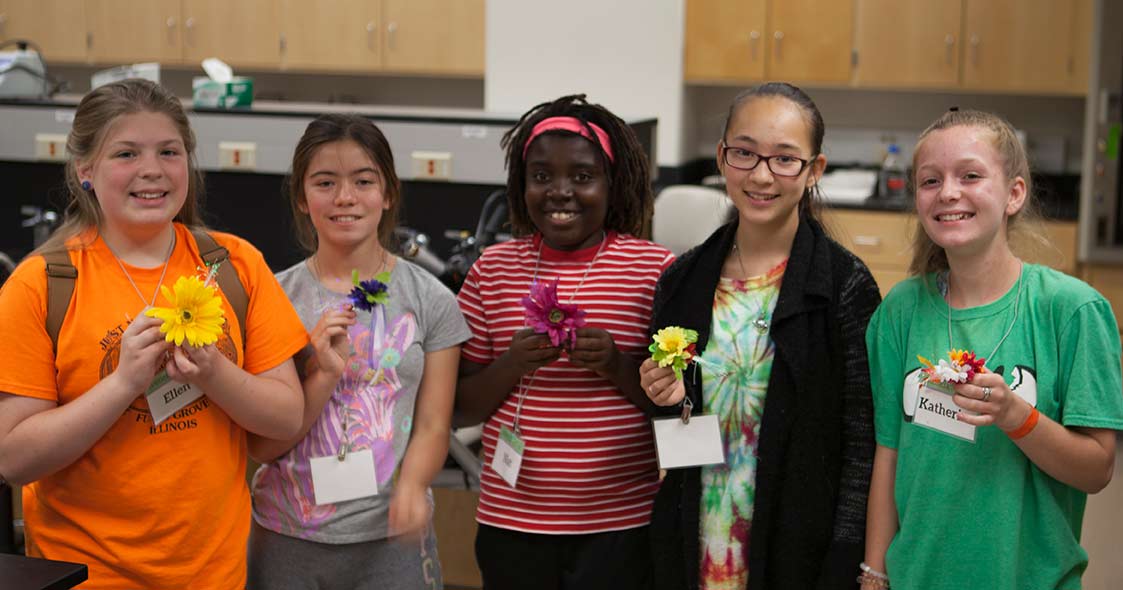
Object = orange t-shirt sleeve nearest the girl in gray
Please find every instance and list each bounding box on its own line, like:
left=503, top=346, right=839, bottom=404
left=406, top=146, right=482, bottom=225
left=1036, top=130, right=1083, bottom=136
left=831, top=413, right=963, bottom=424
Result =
left=222, top=238, right=309, bottom=374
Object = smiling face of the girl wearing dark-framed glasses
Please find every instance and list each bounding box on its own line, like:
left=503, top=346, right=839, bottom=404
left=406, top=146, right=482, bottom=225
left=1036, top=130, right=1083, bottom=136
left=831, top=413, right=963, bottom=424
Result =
left=718, top=96, right=827, bottom=230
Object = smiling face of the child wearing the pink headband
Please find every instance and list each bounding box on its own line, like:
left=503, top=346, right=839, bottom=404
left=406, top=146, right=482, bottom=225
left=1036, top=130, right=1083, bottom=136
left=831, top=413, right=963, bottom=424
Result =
left=524, top=134, right=609, bottom=251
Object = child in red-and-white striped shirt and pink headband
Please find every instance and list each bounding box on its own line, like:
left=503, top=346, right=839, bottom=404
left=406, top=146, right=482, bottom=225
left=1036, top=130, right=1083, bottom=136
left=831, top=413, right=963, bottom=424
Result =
left=456, top=96, right=673, bottom=590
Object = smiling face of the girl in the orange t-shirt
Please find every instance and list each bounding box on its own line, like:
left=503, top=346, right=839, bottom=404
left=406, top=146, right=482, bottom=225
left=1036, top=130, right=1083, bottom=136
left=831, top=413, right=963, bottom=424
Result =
left=77, top=111, right=189, bottom=240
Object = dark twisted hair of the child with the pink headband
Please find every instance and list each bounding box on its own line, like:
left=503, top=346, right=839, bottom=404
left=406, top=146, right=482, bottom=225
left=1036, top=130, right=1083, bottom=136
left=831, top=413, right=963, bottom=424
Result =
left=500, top=94, right=655, bottom=236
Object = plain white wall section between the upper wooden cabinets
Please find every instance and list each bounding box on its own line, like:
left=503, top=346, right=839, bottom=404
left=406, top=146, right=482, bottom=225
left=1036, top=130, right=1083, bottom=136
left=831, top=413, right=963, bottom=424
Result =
left=484, top=0, right=685, bottom=165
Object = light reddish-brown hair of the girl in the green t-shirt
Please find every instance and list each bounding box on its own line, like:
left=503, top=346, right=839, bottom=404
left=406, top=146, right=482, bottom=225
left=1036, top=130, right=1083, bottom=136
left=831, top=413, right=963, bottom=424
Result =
left=909, top=109, right=1056, bottom=275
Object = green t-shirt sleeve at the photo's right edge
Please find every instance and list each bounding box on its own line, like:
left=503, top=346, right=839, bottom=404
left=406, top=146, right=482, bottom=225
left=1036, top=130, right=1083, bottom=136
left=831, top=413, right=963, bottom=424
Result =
left=1058, top=298, right=1123, bottom=430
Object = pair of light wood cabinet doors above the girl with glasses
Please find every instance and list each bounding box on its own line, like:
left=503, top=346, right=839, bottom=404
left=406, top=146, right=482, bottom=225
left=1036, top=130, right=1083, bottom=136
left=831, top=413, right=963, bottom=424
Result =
left=684, top=0, right=853, bottom=83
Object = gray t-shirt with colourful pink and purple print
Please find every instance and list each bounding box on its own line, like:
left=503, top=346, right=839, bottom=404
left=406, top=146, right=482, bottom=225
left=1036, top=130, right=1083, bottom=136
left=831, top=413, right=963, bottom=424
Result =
left=253, top=258, right=471, bottom=544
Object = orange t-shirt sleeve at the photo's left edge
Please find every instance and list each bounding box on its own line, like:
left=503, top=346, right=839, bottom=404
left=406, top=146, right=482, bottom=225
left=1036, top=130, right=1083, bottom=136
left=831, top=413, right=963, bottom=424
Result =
left=0, top=256, right=58, bottom=401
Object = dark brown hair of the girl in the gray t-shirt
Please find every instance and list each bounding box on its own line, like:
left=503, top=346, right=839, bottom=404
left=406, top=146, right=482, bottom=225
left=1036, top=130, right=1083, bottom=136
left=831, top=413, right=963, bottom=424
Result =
left=286, top=114, right=402, bottom=254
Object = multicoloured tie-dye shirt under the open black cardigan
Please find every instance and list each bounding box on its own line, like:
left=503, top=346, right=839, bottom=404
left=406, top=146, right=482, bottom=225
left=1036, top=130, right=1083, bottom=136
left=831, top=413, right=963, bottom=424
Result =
left=699, top=261, right=787, bottom=590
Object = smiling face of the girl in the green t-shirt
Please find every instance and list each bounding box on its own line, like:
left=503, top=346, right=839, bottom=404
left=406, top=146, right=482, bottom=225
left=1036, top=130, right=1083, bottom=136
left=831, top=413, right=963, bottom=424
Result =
left=914, top=126, right=1026, bottom=258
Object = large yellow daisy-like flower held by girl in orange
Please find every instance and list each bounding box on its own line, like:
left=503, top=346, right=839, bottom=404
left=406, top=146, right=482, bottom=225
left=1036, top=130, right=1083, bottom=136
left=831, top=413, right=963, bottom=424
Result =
left=145, top=276, right=226, bottom=346
